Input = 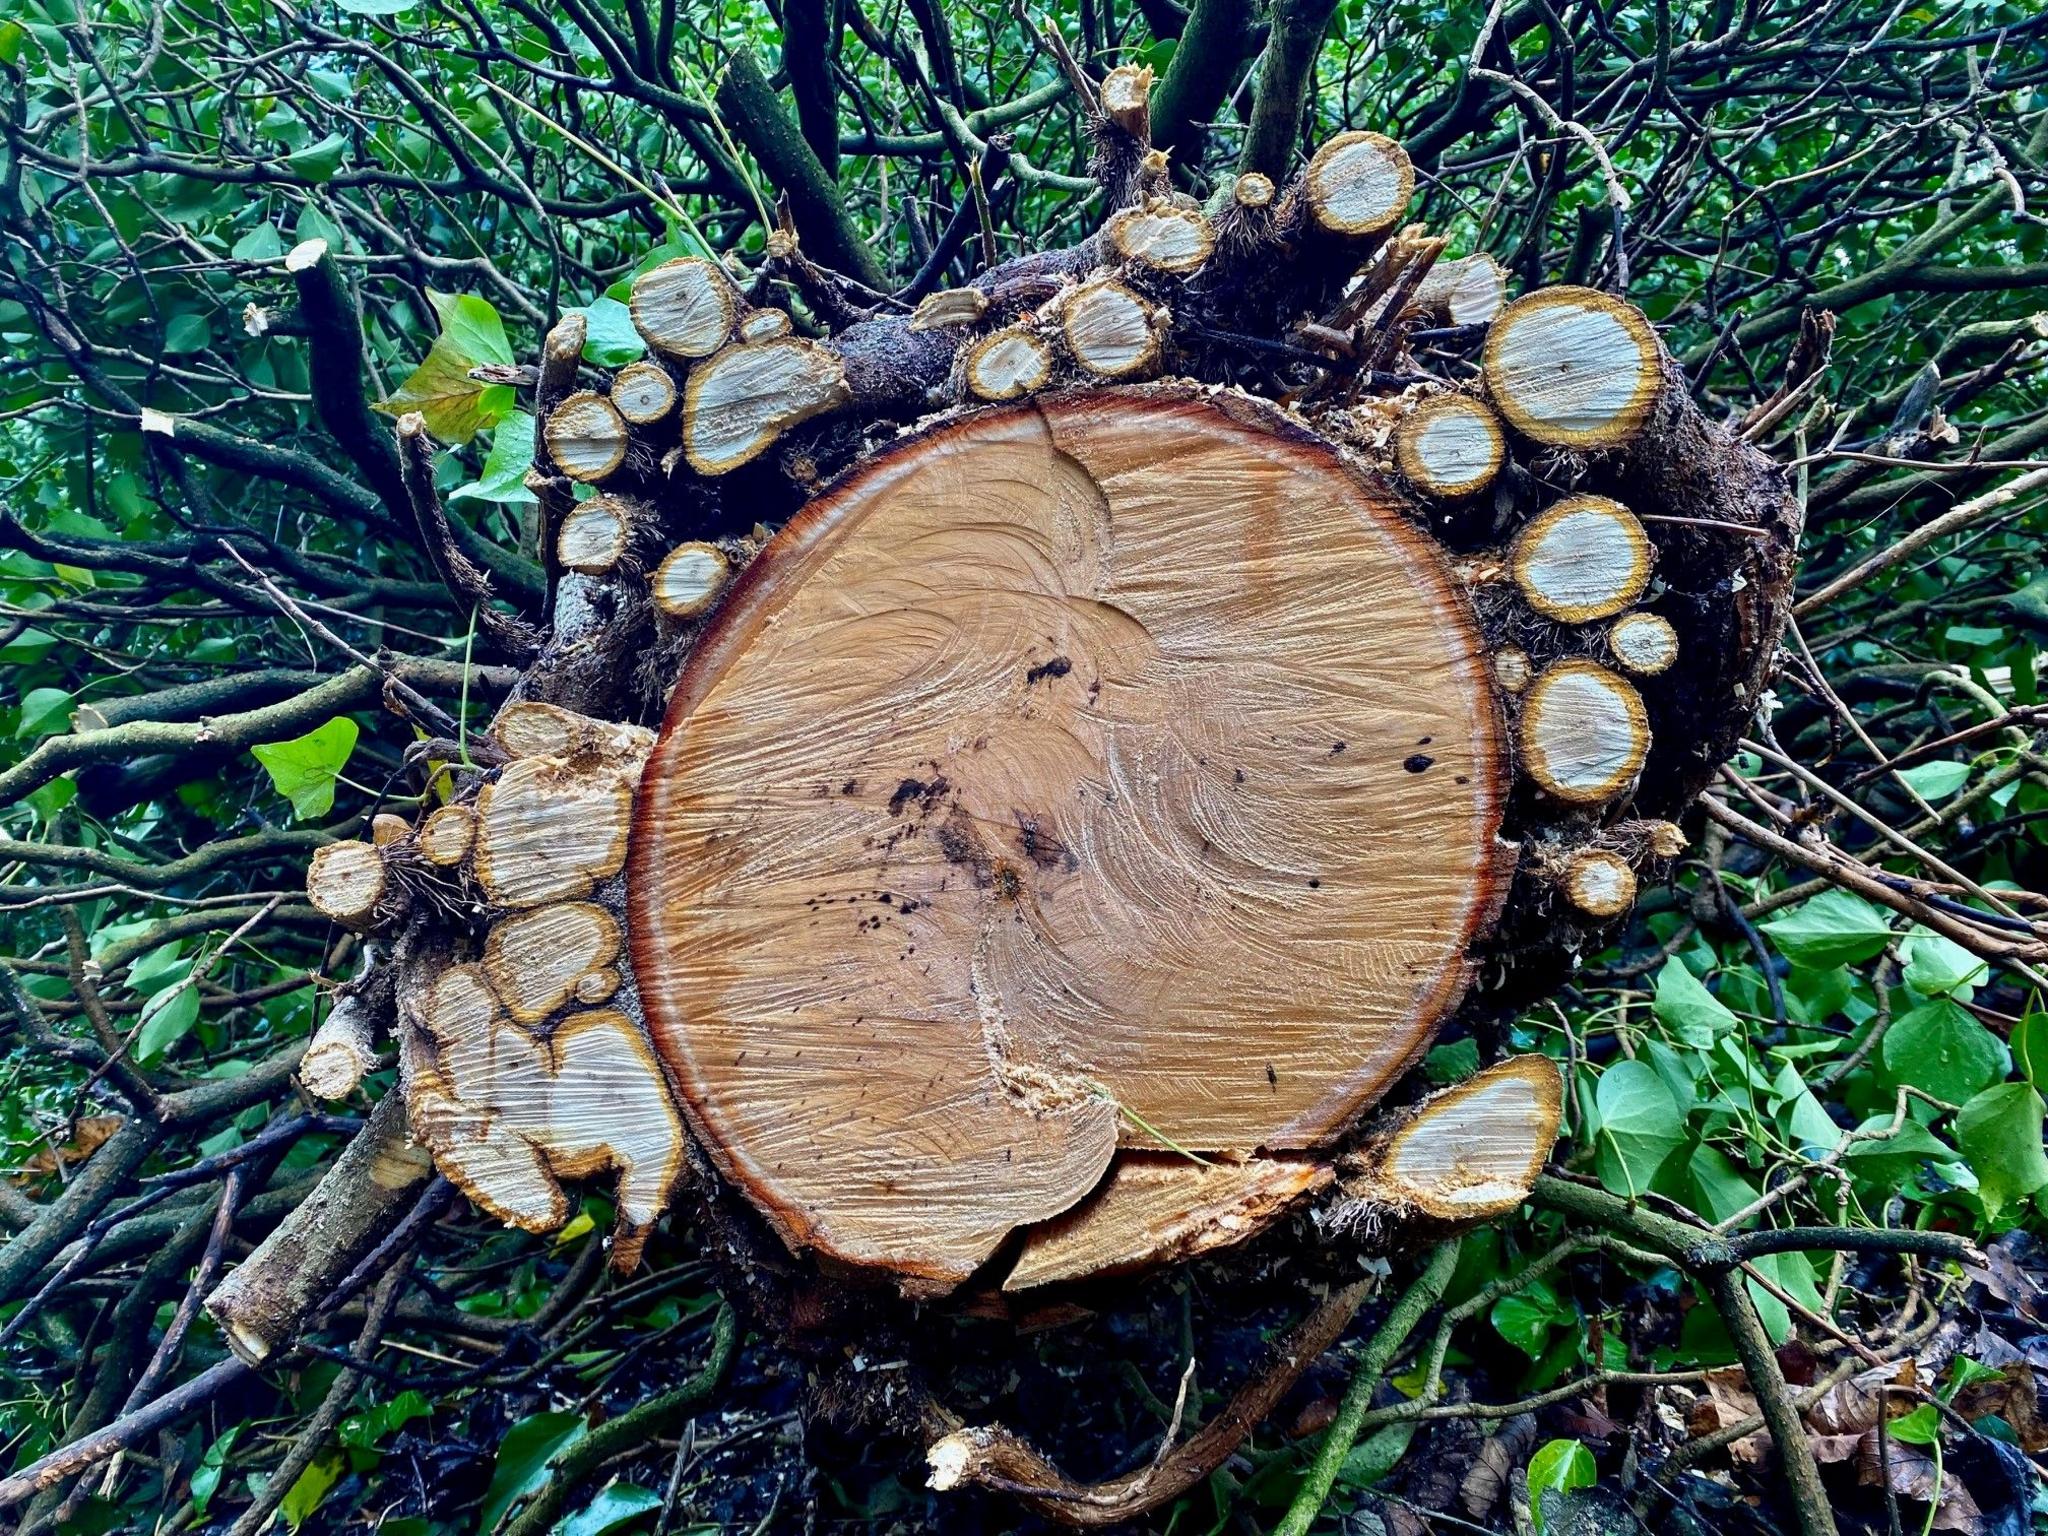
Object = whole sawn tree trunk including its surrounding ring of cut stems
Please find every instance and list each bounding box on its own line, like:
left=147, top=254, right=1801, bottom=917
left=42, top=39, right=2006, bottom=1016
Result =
left=215, top=68, right=1798, bottom=1524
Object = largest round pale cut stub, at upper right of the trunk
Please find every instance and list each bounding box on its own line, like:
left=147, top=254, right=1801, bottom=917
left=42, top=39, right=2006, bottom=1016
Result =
left=1483, top=287, right=1665, bottom=449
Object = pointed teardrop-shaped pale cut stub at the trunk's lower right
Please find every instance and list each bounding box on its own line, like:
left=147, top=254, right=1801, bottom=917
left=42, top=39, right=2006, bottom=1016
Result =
left=1341, top=1057, right=1565, bottom=1223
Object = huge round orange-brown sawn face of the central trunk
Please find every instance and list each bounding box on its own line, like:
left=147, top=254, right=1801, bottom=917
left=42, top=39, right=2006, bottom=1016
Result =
left=627, top=393, right=1509, bottom=1290
